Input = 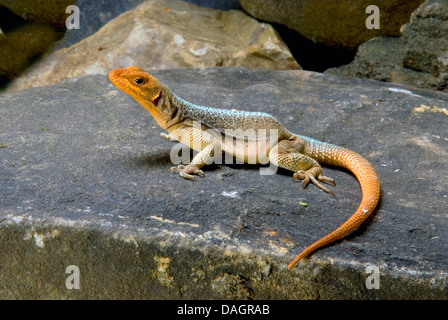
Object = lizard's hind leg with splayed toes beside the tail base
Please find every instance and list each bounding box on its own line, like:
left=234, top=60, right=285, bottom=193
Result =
left=269, top=140, right=336, bottom=195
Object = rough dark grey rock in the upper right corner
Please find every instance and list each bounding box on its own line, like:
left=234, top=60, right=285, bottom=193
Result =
left=326, top=0, right=448, bottom=91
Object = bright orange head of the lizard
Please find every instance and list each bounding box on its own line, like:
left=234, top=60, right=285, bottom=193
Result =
left=109, top=66, right=162, bottom=110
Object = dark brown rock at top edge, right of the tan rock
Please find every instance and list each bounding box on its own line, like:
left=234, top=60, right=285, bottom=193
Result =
left=240, top=0, right=423, bottom=50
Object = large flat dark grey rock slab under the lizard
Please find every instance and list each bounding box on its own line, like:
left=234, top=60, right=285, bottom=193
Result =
left=0, top=67, right=448, bottom=299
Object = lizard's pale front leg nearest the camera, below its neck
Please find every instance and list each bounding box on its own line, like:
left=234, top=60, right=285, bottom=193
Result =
left=170, top=128, right=220, bottom=180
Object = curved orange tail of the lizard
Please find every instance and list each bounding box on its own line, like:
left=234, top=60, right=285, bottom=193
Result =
left=288, top=138, right=380, bottom=269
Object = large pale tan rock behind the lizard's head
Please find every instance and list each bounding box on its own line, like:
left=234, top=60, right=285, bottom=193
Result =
left=9, top=0, right=300, bottom=90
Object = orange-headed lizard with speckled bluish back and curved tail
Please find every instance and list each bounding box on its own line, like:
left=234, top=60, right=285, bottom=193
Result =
left=109, top=66, right=380, bottom=269
